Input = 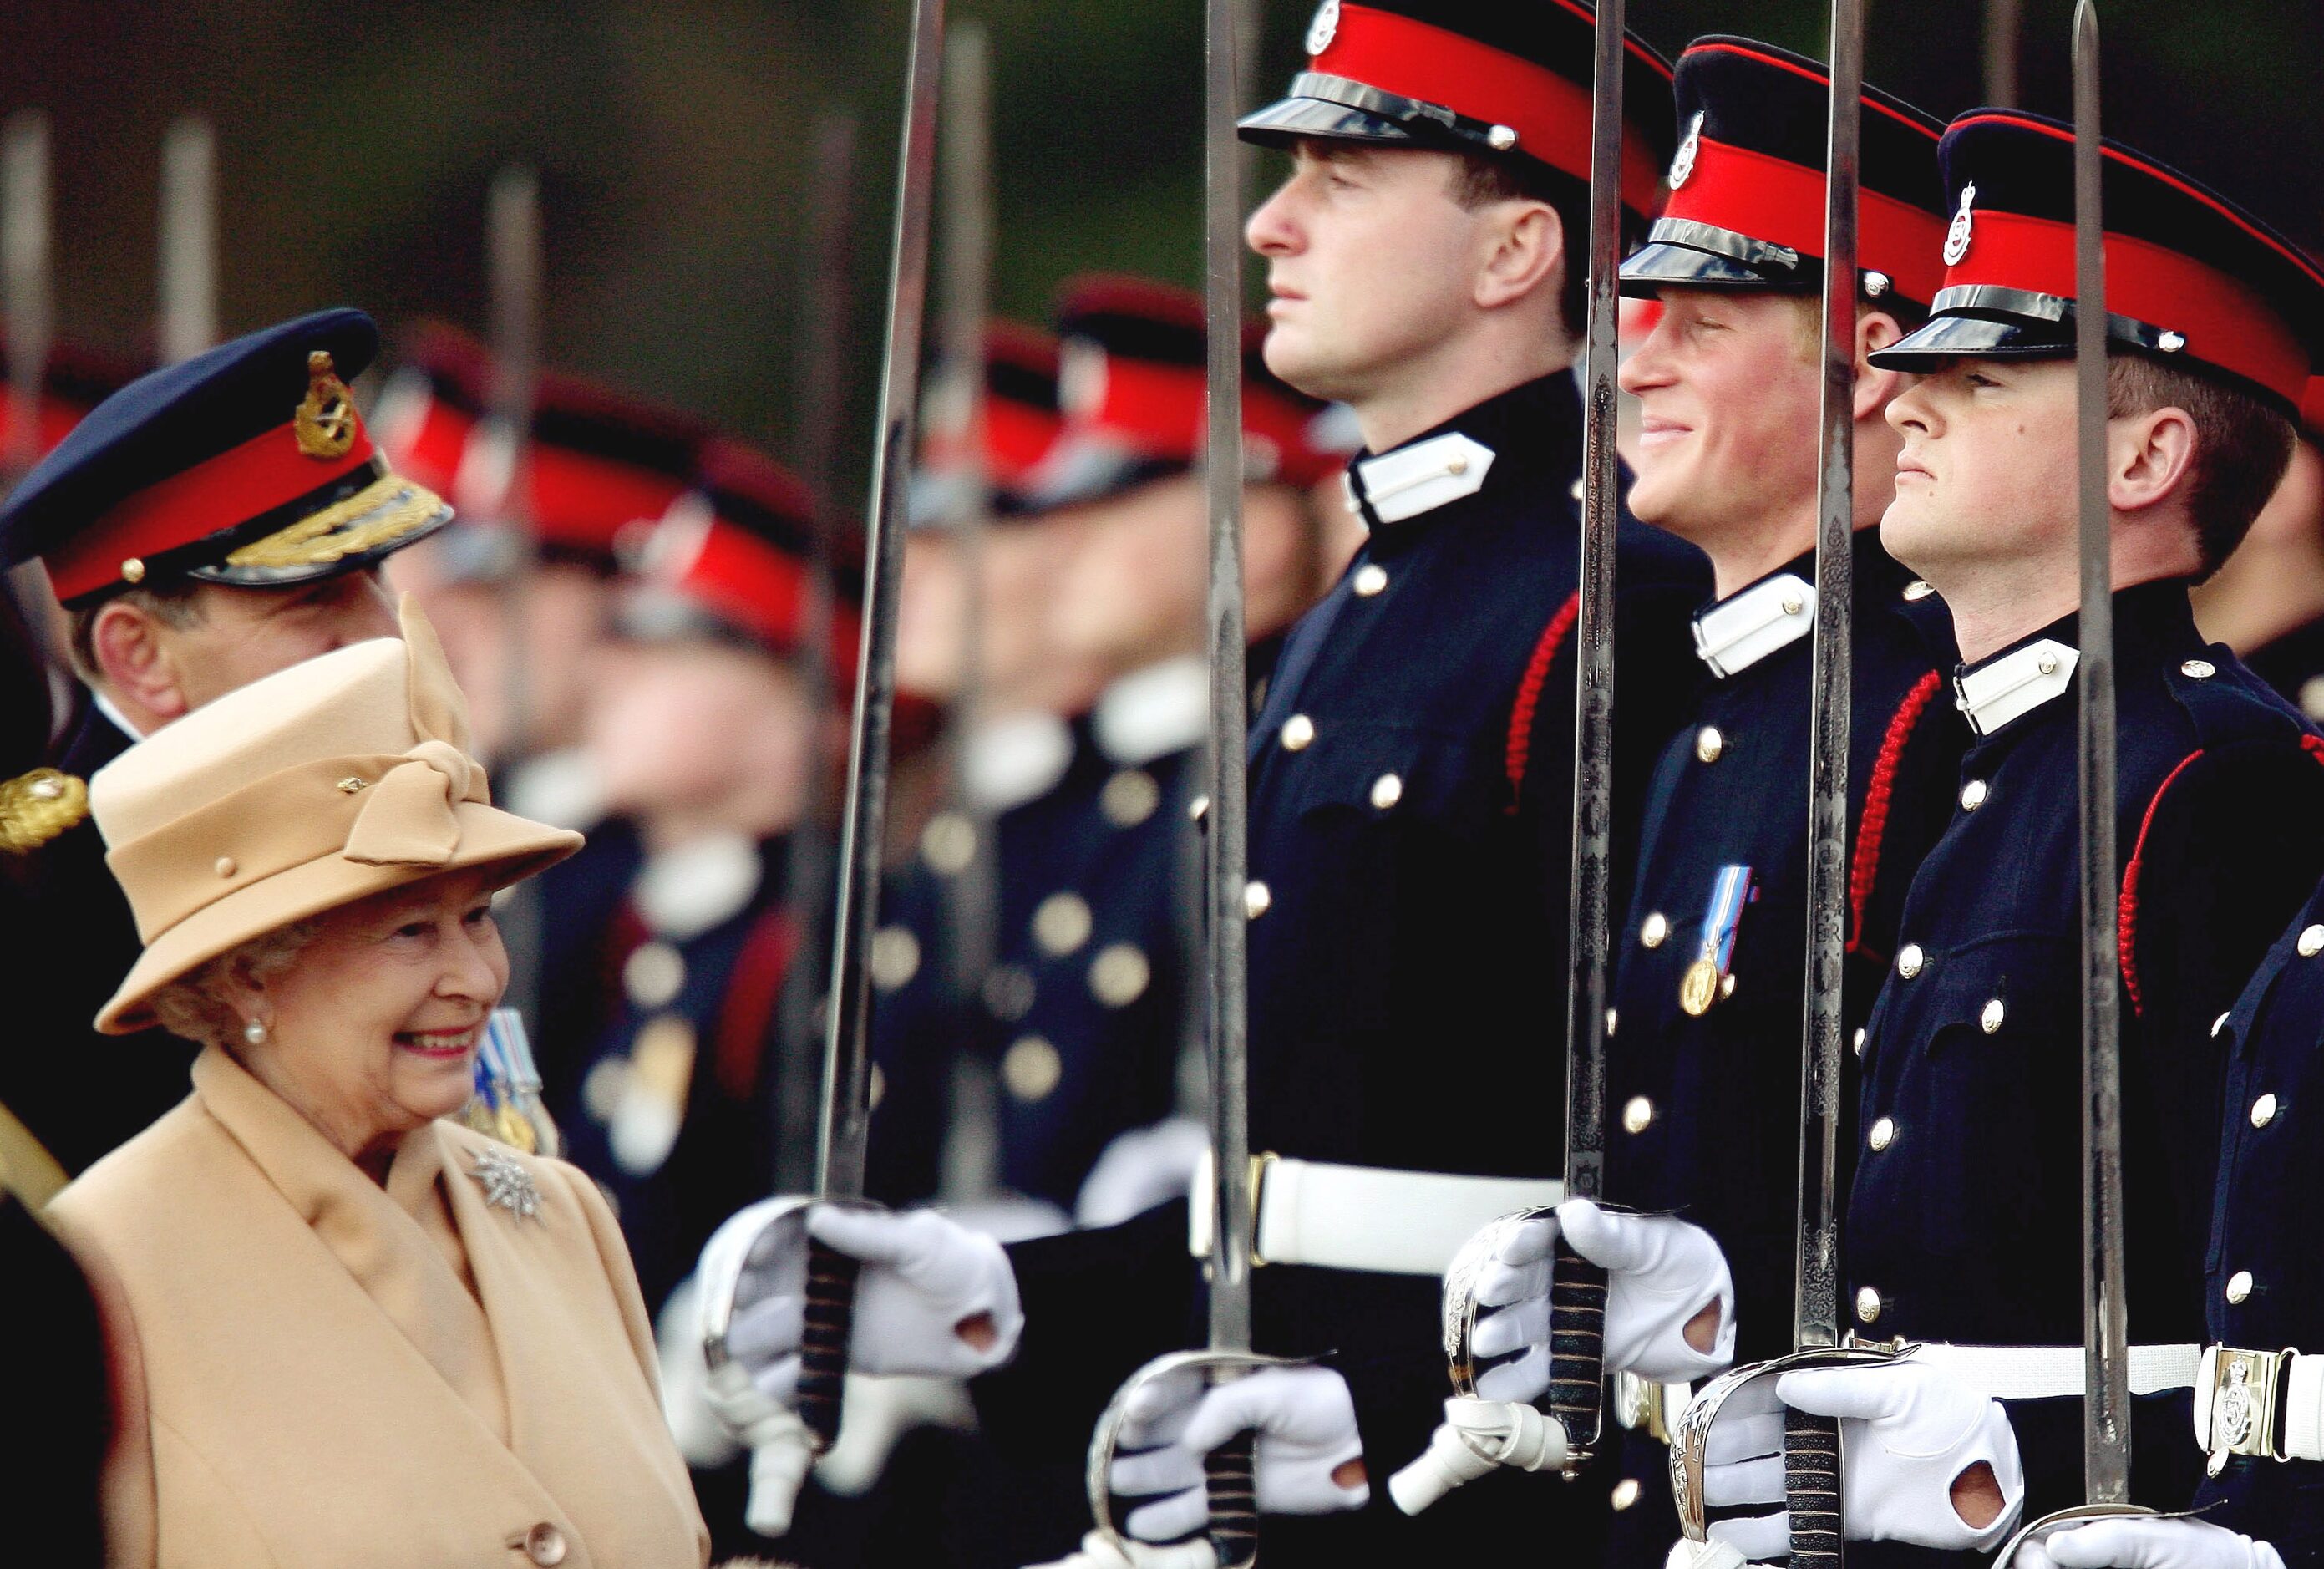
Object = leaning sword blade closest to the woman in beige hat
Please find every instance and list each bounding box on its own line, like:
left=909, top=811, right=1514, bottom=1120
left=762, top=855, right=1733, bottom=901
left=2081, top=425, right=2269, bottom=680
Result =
left=806, top=0, right=943, bottom=1199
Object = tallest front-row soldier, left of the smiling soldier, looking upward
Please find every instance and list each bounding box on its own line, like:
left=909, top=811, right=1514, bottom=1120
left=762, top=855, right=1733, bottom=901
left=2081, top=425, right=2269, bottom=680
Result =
left=678, top=0, right=1706, bottom=1564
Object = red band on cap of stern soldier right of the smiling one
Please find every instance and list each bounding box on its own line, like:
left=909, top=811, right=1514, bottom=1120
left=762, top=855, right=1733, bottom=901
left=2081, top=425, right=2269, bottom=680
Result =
left=1946, top=209, right=2308, bottom=404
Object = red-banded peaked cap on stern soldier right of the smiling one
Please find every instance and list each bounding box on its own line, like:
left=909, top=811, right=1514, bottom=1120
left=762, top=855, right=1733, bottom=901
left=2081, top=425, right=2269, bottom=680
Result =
left=1871, top=109, right=2324, bottom=416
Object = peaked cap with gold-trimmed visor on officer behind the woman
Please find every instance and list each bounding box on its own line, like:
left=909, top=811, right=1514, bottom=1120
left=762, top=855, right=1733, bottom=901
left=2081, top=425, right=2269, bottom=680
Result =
left=0, top=309, right=451, bottom=607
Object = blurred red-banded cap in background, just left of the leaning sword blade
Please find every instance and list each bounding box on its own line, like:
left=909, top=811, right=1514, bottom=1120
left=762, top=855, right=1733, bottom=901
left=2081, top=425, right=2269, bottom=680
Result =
left=621, top=442, right=862, bottom=672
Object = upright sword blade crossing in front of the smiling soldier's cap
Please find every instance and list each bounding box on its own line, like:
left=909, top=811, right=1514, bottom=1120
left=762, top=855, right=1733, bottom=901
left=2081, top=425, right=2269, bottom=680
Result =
left=1792, top=0, right=1864, bottom=1348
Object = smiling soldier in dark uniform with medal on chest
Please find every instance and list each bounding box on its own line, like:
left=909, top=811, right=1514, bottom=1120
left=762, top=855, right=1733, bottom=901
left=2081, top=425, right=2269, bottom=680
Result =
left=1440, top=38, right=1966, bottom=1562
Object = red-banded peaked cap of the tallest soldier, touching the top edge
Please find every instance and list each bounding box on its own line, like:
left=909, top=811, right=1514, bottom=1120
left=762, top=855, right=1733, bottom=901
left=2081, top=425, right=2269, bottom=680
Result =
left=1241, top=0, right=1676, bottom=219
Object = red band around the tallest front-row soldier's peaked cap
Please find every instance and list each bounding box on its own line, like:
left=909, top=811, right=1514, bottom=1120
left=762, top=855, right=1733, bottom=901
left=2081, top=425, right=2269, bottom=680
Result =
left=1311, top=5, right=1662, bottom=214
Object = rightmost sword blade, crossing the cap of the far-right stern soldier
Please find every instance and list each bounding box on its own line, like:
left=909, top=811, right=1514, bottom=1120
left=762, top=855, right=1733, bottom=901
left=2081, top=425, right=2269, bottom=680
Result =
left=2073, top=0, right=2131, bottom=1504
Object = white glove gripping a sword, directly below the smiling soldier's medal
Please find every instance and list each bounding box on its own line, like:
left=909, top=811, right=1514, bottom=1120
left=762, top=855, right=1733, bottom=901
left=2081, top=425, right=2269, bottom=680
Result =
left=1469, top=1200, right=1736, bottom=1402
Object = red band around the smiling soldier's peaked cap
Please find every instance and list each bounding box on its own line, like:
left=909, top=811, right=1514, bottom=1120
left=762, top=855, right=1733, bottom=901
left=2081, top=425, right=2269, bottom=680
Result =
left=1662, top=137, right=1946, bottom=304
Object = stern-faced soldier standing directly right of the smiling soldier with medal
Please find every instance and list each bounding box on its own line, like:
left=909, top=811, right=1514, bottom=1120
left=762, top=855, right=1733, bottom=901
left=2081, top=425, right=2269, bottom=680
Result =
left=1703, top=109, right=2324, bottom=1562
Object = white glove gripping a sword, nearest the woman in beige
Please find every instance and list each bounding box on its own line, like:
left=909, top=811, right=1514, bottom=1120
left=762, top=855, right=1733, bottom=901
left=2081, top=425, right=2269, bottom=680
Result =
left=702, top=1200, right=1025, bottom=1406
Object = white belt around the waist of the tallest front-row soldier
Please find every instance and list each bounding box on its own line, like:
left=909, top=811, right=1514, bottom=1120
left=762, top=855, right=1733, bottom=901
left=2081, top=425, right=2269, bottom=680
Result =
left=1185, top=1153, right=1564, bottom=1274
